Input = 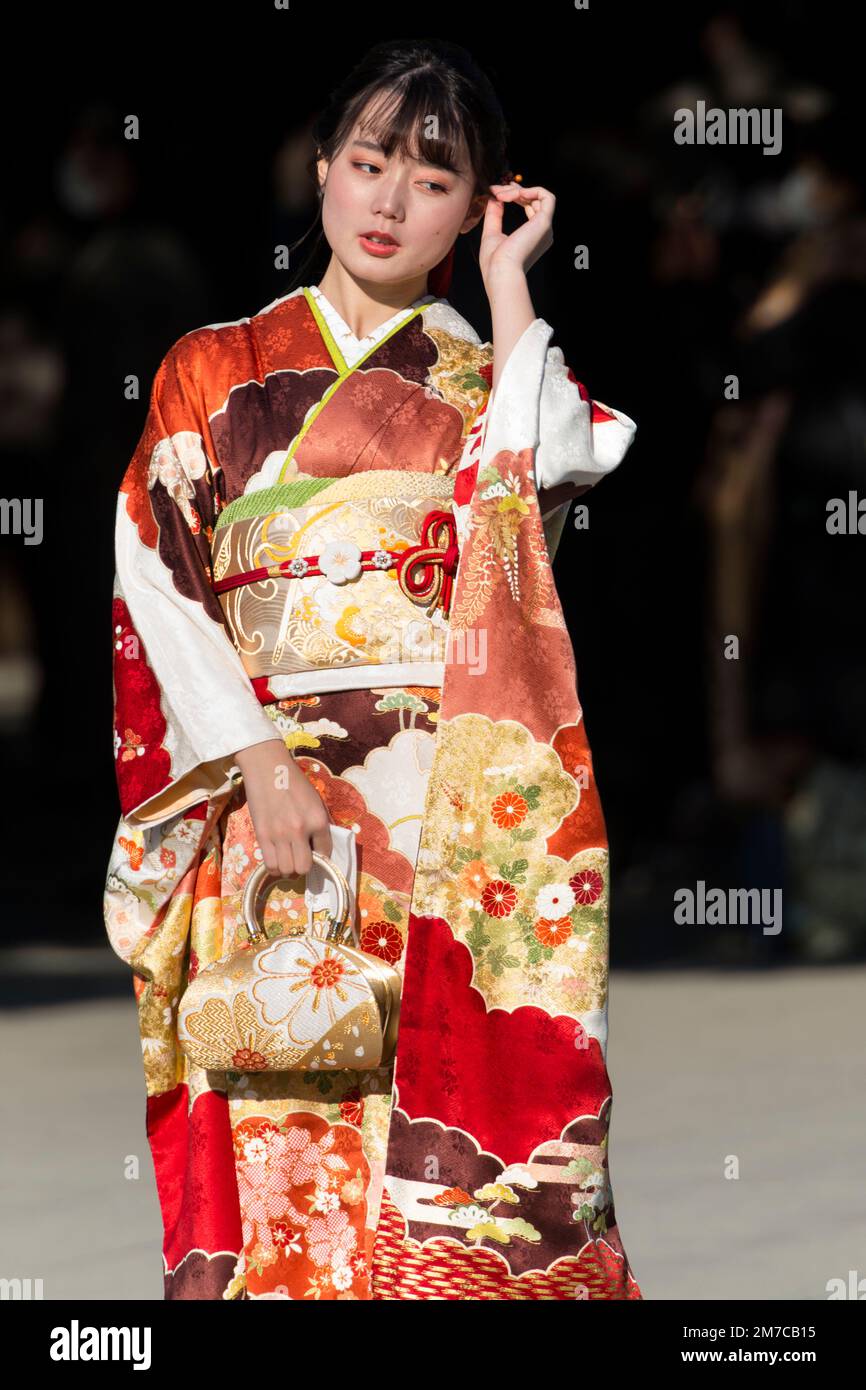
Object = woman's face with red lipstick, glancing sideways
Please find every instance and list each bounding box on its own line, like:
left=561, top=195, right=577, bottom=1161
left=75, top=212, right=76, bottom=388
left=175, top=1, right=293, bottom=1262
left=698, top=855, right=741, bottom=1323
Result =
left=318, top=100, right=487, bottom=291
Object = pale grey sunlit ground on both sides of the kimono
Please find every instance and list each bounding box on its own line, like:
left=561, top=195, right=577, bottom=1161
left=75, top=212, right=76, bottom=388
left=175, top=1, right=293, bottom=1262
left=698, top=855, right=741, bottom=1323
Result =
left=0, top=949, right=866, bottom=1300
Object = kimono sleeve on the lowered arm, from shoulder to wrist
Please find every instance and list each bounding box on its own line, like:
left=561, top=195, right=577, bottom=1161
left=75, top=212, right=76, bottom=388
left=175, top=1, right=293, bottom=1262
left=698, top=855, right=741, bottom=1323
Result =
left=113, top=335, right=278, bottom=826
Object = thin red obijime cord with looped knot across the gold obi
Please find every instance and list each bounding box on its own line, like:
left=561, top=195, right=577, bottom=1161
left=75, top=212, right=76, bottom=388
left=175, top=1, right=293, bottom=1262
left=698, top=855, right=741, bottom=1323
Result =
left=211, top=510, right=459, bottom=616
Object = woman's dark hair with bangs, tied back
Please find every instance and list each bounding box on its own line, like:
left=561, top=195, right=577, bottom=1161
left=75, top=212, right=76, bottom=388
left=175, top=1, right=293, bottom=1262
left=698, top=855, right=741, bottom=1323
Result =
left=292, top=39, right=513, bottom=288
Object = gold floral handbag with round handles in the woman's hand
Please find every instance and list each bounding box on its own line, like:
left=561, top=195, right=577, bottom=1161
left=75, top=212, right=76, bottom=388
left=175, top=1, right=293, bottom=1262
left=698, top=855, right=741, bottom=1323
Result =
left=178, top=851, right=402, bottom=1072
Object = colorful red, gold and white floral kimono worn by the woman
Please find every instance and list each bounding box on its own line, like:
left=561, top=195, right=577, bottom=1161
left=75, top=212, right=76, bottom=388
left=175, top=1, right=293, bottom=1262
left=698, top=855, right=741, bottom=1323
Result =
left=104, top=288, right=641, bottom=1300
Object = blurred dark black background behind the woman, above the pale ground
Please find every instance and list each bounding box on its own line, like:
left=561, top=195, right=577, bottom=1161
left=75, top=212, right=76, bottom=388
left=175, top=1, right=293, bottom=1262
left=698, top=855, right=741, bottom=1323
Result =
left=0, top=0, right=866, bottom=987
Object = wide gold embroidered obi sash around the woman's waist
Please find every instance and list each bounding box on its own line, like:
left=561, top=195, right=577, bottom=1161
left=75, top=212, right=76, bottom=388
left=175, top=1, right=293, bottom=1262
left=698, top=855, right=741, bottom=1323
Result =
left=211, top=470, right=457, bottom=696
